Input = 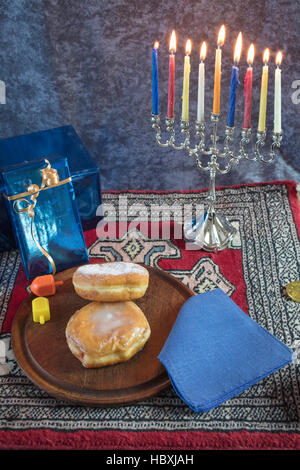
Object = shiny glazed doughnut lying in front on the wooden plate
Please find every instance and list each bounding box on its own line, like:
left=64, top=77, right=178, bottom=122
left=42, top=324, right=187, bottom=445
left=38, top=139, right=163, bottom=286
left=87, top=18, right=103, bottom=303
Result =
left=65, top=301, right=150, bottom=367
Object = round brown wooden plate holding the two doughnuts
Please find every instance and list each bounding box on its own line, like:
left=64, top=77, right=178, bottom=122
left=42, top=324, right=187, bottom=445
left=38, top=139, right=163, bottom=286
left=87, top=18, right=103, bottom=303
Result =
left=12, top=266, right=193, bottom=406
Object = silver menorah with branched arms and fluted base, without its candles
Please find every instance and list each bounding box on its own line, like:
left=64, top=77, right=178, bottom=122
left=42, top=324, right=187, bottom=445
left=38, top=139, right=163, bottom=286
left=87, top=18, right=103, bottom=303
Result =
left=152, top=113, right=282, bottom=251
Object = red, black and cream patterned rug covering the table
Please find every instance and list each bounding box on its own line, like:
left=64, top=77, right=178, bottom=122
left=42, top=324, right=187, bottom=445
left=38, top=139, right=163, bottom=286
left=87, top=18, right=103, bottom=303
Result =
left=0, top=181, right=300, bottom=450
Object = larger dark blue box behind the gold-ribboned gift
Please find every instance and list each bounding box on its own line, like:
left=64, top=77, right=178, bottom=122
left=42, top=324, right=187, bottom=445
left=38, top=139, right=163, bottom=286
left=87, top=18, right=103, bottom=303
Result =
left=0, top=126, right=101, bottom=251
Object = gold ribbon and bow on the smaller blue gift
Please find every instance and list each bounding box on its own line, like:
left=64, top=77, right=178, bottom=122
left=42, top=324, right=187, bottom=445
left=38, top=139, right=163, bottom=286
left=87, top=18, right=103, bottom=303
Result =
left=4, top=160, right=72, bottom=275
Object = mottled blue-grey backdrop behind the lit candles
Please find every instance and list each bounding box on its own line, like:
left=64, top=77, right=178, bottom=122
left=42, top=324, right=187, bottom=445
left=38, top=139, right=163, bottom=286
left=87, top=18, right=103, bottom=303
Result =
left=0, top=0, right=300, bottom=189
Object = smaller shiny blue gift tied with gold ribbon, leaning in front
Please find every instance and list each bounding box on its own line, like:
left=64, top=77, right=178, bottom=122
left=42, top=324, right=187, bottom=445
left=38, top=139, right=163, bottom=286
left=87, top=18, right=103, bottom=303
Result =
left=1, top=157, right=89, bottom=279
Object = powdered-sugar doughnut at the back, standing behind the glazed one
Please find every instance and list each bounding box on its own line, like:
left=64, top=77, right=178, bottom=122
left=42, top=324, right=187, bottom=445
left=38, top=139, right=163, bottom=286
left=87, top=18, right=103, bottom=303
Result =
left=73, top=261, right=149, bottom=302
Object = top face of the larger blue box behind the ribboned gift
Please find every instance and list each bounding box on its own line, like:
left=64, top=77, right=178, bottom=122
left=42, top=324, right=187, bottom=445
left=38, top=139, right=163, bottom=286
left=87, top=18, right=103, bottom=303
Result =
left=0, top=125, right=99, bottom=191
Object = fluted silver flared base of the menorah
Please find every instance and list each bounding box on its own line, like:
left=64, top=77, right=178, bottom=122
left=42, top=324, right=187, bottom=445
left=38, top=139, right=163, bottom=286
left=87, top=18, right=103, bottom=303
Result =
left=184, top=205, right=236, bottom=251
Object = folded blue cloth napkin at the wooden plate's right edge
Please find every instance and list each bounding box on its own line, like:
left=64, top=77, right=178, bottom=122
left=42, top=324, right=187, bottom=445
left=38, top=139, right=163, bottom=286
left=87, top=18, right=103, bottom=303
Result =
left=158, top=289, right=293, bottom=412
